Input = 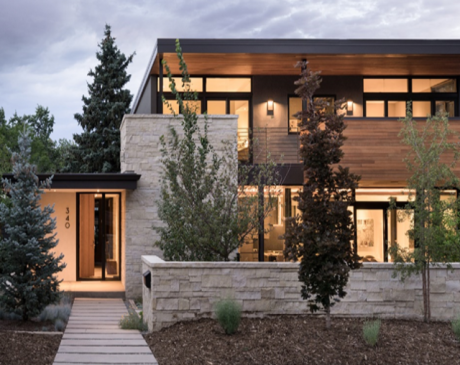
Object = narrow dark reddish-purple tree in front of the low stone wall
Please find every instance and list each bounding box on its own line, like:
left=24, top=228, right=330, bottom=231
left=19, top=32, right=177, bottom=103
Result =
left=284, top=62, right=361, bottom=328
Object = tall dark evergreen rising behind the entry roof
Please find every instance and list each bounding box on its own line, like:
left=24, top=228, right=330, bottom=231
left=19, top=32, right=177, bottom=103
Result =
left=64, top=25, right=134, bottom=173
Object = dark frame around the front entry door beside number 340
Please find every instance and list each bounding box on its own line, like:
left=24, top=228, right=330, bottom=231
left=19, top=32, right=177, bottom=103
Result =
left=76, top=191, right=122, bottom=281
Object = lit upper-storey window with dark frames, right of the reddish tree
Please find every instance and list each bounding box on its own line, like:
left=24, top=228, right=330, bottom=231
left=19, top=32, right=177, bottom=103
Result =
left=363, top=77, right=458, bottom=118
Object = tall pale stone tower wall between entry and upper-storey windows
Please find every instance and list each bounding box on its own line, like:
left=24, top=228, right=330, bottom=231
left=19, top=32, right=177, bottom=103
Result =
left=120, top=114, right=238, bottom=298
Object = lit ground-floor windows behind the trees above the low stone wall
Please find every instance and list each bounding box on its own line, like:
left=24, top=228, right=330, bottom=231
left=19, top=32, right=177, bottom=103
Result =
left=239, top=186, right=457, bottom=262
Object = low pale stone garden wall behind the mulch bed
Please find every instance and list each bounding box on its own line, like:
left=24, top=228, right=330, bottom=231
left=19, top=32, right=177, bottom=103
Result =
left=142, top=256, right=460, bottom=331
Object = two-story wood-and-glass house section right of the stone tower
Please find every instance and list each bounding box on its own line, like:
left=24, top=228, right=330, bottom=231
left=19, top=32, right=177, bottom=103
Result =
left=128, top=39, right=460, bottom=268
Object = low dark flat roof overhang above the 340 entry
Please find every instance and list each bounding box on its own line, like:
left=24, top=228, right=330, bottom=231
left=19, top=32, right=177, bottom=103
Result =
left=3, top=173, right=141, bottom=190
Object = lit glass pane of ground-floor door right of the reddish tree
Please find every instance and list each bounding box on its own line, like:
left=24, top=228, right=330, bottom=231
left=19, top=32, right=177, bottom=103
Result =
left=356, top=209, right=385, bottom=262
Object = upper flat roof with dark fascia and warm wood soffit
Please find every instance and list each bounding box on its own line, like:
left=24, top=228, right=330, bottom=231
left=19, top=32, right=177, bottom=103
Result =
left=132, top=38, right=460, bottom=112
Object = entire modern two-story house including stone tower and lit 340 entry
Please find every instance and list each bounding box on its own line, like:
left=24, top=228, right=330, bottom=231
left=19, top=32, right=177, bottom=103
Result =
left=3, top=39, right=460, bottom=297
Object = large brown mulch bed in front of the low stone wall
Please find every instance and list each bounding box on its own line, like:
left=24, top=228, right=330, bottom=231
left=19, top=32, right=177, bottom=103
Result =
left=145, top=316, right=460, bottom=365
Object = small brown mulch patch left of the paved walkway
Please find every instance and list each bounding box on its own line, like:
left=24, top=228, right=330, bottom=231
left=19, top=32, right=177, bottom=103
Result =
left=0, top=331, right=62, bottom=365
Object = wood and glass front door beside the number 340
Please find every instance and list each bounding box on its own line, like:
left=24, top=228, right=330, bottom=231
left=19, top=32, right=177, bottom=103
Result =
left=77, top=193, right=121, bottom=280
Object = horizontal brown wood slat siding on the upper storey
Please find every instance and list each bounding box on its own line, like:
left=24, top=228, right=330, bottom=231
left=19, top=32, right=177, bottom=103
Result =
left=254, top=118, right=460, bottom=186
